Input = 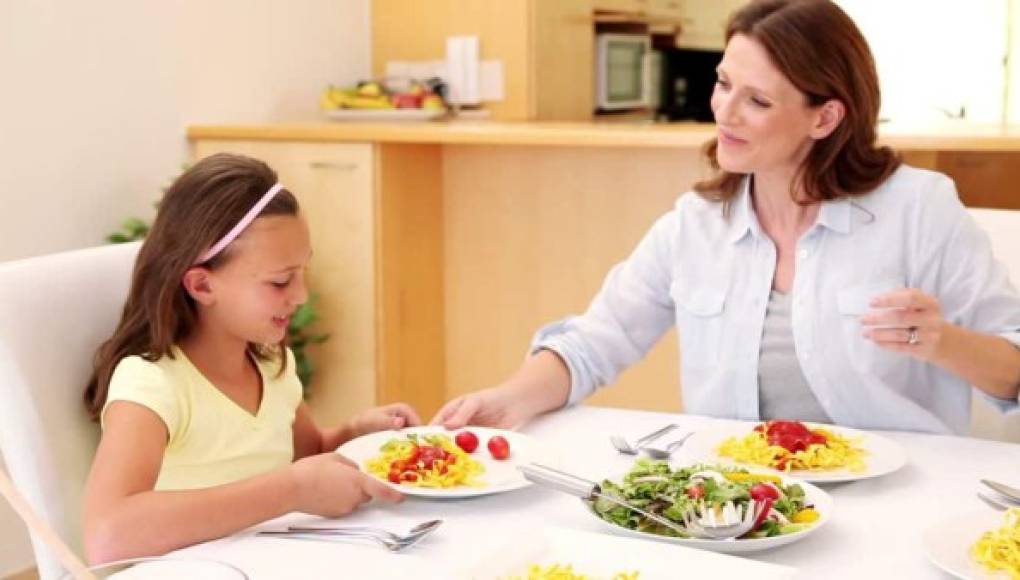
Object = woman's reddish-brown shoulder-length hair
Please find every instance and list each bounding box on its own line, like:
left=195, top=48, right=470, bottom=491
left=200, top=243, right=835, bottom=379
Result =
left=694, top=0, right=901, bottom=203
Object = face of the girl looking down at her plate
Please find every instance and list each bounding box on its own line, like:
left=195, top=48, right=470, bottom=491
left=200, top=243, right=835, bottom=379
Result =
left=199, top=216, right=311, bottom=345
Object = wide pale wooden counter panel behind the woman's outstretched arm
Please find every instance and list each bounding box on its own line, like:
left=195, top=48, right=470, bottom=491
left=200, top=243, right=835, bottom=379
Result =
left=444, top=146, right=714, bottom=411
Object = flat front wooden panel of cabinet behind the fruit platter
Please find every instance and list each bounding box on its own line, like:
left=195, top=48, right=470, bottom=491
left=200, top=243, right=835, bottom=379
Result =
left=372, top=0, right=531, bottom=120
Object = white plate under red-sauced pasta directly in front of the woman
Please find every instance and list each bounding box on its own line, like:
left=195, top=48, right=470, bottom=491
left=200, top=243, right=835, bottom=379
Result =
left=681, top=421, right=907, bottom=483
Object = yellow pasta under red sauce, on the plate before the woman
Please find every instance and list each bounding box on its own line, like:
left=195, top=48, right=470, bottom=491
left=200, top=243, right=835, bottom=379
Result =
left=717, top=428, right=867, bottom=472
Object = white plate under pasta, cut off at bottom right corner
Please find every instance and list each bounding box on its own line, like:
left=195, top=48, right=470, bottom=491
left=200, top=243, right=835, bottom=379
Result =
left=921, top=509, right=1010, bottom=580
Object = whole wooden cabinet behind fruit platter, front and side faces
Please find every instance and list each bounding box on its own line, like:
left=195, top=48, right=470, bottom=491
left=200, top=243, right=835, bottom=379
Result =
left=372, top=0, right=591, bottom=120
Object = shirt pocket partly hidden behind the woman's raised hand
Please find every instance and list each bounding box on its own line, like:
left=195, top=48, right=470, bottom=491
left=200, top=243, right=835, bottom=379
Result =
left=836, top=276, right=909, bottom=379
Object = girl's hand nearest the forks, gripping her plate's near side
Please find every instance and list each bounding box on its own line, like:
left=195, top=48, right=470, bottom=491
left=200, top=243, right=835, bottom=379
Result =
left=291, top=454, right=404, bottom=518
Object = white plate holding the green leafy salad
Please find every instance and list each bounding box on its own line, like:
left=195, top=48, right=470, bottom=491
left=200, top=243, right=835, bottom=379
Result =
left=582, top=470, right=832, bottom=553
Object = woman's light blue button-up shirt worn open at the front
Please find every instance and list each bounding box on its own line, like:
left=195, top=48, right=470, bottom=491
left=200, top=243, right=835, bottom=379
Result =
left=532, top=166, right=1020, bottom=434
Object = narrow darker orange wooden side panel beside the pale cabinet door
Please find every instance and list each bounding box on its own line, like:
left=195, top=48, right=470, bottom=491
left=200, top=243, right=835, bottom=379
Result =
left=376, top=145, right=446, bottom=420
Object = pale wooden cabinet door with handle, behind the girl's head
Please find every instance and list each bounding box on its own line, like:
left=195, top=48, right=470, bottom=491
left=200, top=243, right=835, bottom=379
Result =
left=195, top=141, right=376, bottom=425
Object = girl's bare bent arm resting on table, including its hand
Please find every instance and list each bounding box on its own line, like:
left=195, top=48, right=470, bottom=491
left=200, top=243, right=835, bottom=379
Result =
left=85, top=402, right=400, bottom=563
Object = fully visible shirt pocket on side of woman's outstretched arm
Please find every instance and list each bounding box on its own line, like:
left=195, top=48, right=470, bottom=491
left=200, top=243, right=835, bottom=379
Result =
left=669, top=282, right=726, bottom=367
